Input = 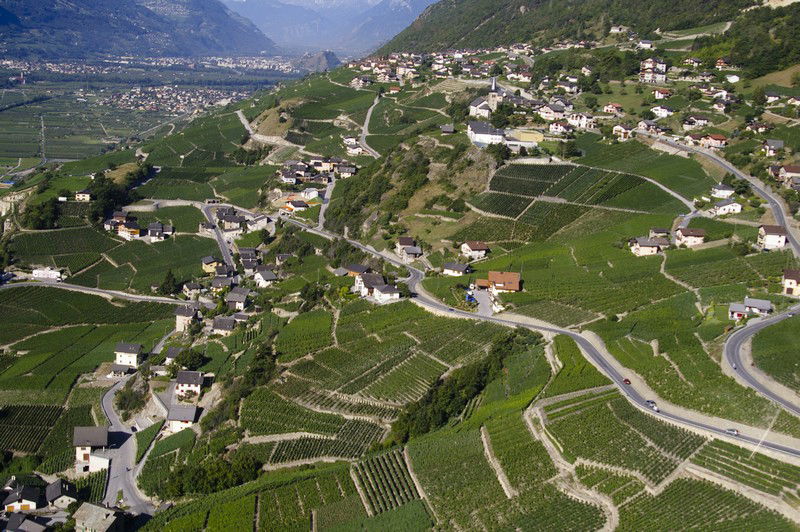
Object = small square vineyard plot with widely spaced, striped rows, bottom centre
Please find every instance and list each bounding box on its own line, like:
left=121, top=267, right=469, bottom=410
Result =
left=353, top=450, right=419, bottom=514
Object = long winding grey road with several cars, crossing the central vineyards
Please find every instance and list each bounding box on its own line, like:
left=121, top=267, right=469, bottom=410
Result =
left=287, top=216, right=800, bottom=458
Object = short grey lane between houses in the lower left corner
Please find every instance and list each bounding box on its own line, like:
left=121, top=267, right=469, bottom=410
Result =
left=102, top=377, right=155, bottom=515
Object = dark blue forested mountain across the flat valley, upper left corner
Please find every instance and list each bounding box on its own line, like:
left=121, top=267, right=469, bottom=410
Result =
left=0, top=0, right=276, bottom=58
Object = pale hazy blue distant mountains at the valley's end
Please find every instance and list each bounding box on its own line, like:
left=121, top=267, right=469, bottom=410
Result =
left=225, top=0, right=435, bottom=55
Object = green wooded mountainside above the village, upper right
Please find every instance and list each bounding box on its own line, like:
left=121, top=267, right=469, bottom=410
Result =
left=378, top=0, right=758, bottom=54
